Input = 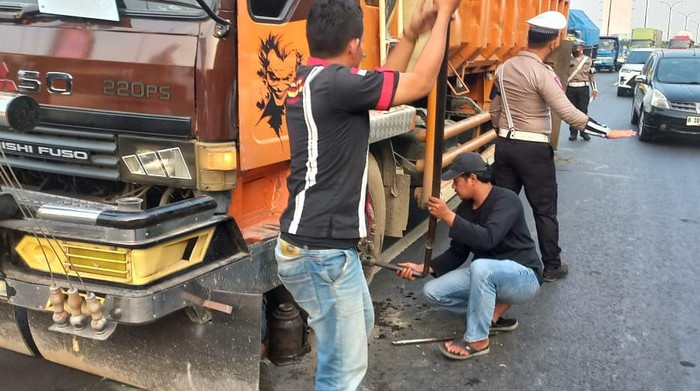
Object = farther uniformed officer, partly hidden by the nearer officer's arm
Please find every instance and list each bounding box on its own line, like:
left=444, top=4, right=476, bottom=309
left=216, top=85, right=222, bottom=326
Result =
left=566, top=40, right=598, bottom=141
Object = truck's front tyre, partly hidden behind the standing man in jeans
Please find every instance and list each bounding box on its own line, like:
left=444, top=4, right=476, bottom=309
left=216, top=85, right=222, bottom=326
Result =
left=364, top=154, right=386, bottom=284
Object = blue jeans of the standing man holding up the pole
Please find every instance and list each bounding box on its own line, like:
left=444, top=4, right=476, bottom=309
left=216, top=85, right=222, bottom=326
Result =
left=275, top=239, right=374, bottom=391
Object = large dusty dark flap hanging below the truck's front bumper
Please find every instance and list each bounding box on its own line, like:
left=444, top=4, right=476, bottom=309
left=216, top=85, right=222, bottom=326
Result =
left=28, top=292, right=262, bottom=391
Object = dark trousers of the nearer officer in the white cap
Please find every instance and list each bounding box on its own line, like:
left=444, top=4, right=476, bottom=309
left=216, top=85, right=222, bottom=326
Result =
left=494, top=137, right=561, bottom=268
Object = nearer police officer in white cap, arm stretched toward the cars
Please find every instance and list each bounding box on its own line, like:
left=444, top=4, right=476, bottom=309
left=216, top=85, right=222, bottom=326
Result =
left=489, top=11, right=635, bottom=282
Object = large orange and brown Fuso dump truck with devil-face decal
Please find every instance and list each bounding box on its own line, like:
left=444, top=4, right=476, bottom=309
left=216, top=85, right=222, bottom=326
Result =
left=0, top=0, right=569, bottom=390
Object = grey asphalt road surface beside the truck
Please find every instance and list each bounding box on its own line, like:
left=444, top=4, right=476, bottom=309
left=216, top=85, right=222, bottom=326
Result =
left=0, top=74, right=700, bottom=391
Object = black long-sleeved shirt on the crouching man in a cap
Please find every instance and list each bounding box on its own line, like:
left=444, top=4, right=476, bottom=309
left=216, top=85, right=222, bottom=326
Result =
left=431, top=186, right=544, bottom=283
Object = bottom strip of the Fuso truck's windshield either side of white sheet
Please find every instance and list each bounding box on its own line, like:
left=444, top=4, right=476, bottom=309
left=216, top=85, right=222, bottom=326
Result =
left=0, top=0, right=218, bottom=17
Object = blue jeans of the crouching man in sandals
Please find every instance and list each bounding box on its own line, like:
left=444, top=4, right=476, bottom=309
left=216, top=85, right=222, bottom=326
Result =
left=423, top=258, right=540, bottom=342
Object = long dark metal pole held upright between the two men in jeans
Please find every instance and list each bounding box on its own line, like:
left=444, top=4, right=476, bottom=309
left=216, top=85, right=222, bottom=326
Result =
left=421, top=25, right=450, bottom=277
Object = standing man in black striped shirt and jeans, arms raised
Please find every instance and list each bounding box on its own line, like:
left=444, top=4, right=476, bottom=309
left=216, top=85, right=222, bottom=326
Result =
left=275, top=0, right=459, bottom=390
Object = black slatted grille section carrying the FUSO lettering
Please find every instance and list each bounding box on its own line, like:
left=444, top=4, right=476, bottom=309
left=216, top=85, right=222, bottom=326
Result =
left=0, top=123, right=119, bottom=181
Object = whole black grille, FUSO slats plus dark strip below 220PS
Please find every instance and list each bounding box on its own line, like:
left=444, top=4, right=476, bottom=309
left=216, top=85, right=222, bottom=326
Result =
left=0, top=104, right=192, bottom=181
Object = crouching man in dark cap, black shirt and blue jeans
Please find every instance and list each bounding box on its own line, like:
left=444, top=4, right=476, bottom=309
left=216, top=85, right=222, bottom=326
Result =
left=397, top=152, right=544, bottom=360
